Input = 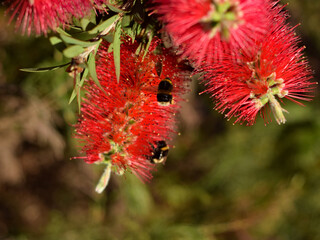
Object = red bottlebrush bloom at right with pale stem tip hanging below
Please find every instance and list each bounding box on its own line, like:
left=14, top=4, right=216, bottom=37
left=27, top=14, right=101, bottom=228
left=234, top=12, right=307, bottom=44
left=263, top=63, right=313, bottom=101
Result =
left=202, top=24, right=315, bottom=125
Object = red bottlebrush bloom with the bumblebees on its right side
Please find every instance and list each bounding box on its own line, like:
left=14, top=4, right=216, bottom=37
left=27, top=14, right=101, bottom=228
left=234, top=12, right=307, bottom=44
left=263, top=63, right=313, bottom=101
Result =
left=76, top=41, right=188, bottom=186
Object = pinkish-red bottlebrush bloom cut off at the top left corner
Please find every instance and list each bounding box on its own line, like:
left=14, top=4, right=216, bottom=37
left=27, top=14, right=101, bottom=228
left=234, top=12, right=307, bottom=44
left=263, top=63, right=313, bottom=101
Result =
left=8, top=0, right=92, bottom=35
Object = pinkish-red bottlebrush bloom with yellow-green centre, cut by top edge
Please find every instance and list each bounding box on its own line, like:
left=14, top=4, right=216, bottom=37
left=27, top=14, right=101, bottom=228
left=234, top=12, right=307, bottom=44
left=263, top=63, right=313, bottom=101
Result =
left=154, top=0, right=283, bottom=66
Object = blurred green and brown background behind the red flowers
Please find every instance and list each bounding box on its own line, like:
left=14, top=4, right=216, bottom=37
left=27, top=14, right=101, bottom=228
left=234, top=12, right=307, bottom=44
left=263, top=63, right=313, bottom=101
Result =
left=0, top=0, right=320, bottom=240
